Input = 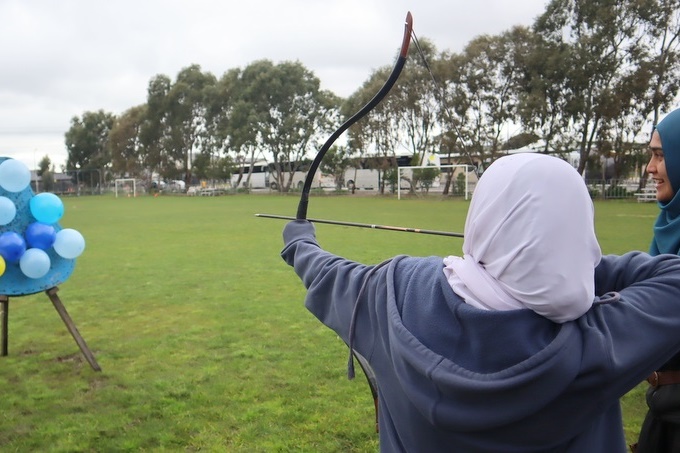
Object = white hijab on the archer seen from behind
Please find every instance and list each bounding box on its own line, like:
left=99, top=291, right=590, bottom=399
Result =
left=444, top=154, right=602, bottom=323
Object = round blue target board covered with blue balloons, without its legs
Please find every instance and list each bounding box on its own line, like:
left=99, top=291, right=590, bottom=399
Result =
left=0, top=157, right=85, bottom=296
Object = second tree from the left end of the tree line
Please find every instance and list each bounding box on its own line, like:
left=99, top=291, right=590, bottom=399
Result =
left=108, top=104, right=151, bottom=180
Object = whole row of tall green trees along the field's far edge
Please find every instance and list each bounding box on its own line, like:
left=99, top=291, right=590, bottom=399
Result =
left=65, top=0, right=680, bottom=191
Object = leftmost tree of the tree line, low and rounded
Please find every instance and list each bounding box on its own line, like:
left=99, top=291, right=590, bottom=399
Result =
left=64, top=110, right=116, bottom=185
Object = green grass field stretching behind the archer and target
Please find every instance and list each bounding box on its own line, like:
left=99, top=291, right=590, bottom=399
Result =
left=0, top=195, right=658, bottom=452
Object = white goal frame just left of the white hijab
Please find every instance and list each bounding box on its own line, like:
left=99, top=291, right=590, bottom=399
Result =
left=397, top=164, right=477, bottom=200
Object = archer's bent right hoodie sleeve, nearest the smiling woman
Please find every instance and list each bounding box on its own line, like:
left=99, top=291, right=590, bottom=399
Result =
left=579, top=252, right=680, bottom=395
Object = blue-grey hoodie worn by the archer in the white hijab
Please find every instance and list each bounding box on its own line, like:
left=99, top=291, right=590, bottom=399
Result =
left=282, top=221, right=680, bottom=453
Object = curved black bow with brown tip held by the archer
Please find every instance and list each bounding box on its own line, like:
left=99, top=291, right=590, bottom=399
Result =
left=296, top=11, right=413, bottom=432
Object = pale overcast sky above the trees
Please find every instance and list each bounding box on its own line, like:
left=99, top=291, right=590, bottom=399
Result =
left=0, top=0, right=548, bottom=170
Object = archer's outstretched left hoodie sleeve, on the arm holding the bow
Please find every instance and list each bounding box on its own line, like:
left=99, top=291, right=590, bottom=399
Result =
left=281, top=220, right=386, bottom=344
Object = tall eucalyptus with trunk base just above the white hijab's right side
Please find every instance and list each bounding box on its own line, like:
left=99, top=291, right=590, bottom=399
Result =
left=534, top=0, right=642, bottom=173
